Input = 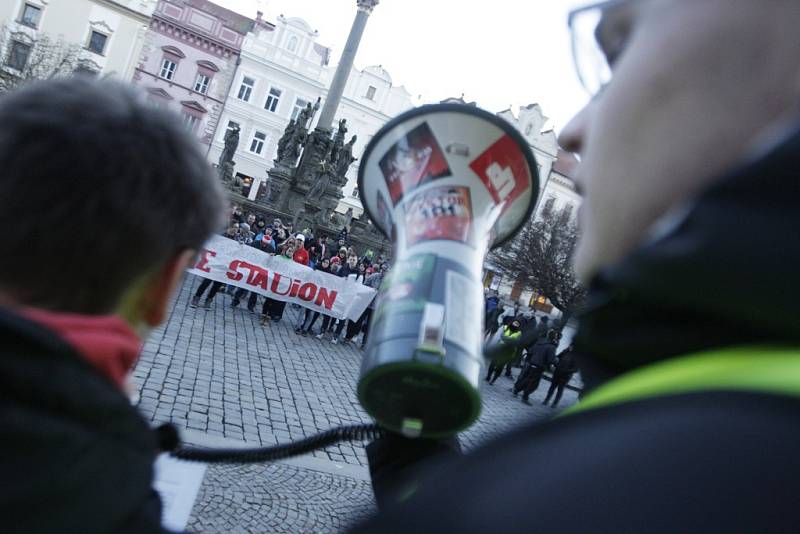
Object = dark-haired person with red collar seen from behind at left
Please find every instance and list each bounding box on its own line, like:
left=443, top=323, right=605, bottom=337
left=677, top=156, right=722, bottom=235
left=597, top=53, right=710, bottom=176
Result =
left=0, top=77, right=224, bottom=534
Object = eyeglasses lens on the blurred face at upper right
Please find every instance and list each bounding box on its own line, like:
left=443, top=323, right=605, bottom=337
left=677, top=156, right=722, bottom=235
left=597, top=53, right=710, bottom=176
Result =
left=567, top=0, right=641, bottom=96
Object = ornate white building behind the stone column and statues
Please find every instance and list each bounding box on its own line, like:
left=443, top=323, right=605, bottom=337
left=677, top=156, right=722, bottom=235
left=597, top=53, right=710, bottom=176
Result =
left=209, top=14, right=412, bottom=217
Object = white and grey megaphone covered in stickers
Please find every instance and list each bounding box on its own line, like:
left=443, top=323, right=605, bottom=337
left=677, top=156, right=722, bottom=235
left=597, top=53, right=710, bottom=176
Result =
left=358, top=104, right=539, bottom=438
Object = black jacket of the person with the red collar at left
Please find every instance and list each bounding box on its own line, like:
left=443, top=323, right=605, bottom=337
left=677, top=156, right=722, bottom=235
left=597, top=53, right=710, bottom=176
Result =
left=0, top=309, right=167, bottom=534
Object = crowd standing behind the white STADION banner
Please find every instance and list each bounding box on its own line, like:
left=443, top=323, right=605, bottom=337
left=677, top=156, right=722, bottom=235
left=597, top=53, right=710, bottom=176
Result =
left=190, top=206, right=389, bottom=348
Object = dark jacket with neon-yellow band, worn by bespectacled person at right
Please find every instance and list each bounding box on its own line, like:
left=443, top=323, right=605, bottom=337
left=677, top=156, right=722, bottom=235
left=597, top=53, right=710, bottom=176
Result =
left=356, top=124, right=800, bottom=534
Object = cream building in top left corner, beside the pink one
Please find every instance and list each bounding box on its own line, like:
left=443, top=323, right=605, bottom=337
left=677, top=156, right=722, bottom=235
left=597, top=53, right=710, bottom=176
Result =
left=0, top=0, right=156, bottom=80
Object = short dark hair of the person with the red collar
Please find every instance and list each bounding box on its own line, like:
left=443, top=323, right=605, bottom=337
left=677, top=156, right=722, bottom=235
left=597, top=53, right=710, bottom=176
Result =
left=0, top=77, right=225, bottom=314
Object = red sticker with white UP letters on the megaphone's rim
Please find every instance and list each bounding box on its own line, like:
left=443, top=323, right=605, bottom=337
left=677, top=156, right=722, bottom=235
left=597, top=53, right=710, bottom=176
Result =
left=469, top=135, right=531, bottom=213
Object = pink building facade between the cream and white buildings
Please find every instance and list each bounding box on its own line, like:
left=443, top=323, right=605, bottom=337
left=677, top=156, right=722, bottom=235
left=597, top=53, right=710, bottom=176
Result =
left=133, top=0, right=254, bottom=148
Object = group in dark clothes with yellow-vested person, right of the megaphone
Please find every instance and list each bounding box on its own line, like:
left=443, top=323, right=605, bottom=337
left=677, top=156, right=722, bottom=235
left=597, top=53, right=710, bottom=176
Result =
left=484, top=290, right=578, bottom=408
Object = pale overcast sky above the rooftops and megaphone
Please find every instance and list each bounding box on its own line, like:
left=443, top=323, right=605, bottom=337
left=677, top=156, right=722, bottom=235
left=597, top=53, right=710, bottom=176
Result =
left=215, top=0, right=587, bottom=131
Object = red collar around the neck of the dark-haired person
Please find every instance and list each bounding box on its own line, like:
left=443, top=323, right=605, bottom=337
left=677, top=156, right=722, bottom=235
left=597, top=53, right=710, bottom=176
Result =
left=20, top=308, right=142, bottom=391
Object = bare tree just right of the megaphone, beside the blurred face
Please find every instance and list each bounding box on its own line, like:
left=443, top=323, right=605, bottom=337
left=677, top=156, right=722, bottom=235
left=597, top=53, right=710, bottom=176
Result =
left=490, top=205, right=586, bottom=322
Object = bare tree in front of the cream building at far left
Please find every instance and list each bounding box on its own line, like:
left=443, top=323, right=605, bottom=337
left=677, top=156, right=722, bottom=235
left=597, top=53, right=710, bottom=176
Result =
left=0, top=24, right=84, bottom=94
